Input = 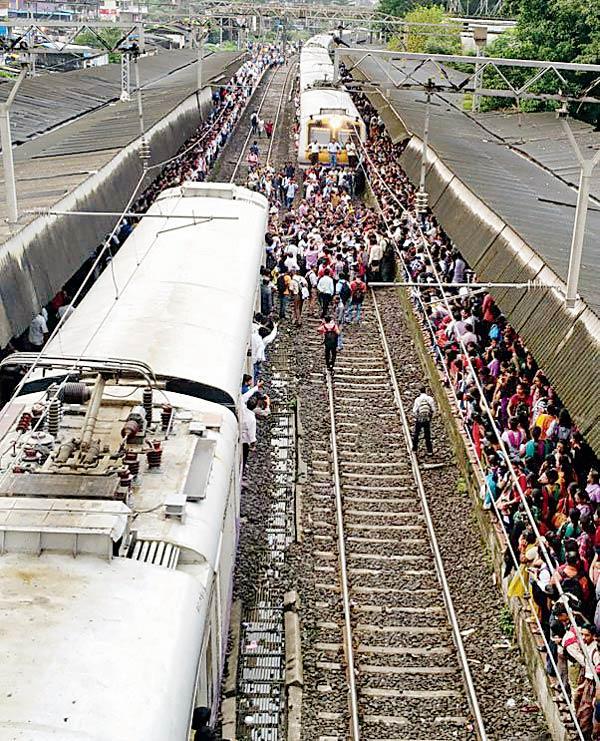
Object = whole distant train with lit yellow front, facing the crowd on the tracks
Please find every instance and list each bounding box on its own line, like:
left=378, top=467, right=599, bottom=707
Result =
left=298, top=34, right=367, bottom=165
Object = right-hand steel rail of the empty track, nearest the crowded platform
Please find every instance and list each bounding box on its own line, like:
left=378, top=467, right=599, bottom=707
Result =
left=371, top=289, right=488, bottom=741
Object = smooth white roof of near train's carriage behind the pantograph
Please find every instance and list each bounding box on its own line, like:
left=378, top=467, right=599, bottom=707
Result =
left=46, top=183, right=268, bottom=405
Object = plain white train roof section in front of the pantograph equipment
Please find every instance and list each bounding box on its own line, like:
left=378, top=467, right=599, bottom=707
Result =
left=0, top=555, right=212, bottom=741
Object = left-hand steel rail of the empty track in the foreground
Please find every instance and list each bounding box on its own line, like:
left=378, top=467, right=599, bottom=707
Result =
left=327, top=373, right=360, bottom=741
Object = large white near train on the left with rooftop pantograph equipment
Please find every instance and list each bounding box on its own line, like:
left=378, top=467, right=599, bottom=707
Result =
left=0, top=184, right=268, bottom=741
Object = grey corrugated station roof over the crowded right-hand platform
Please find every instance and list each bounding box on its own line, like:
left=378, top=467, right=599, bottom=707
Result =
left=346, top=53, right=600, bottom=454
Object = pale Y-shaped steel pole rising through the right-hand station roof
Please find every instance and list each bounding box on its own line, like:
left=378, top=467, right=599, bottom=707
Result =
left=559, top=118, right=600, bottom=309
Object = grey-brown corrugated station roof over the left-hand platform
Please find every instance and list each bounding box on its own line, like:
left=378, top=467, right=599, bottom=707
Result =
left=0, top=49, right=240, bottom=244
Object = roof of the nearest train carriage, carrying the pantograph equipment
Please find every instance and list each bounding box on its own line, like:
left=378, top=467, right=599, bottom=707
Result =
left=0, top=388, right=238, bottom=741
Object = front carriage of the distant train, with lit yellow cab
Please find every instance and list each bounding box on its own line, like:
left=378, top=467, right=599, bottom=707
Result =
left=298, top=88, right=367, bottom=165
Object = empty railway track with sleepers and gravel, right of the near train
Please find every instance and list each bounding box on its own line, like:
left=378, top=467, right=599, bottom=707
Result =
left=305, top=294, right=486, bottom=741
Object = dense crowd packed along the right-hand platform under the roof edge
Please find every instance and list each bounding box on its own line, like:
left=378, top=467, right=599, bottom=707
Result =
left=350, top=89, right=600, bottom=739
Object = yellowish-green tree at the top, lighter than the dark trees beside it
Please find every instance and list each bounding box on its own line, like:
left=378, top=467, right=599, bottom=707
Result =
left=389, top=5, right=460, bottom=54
